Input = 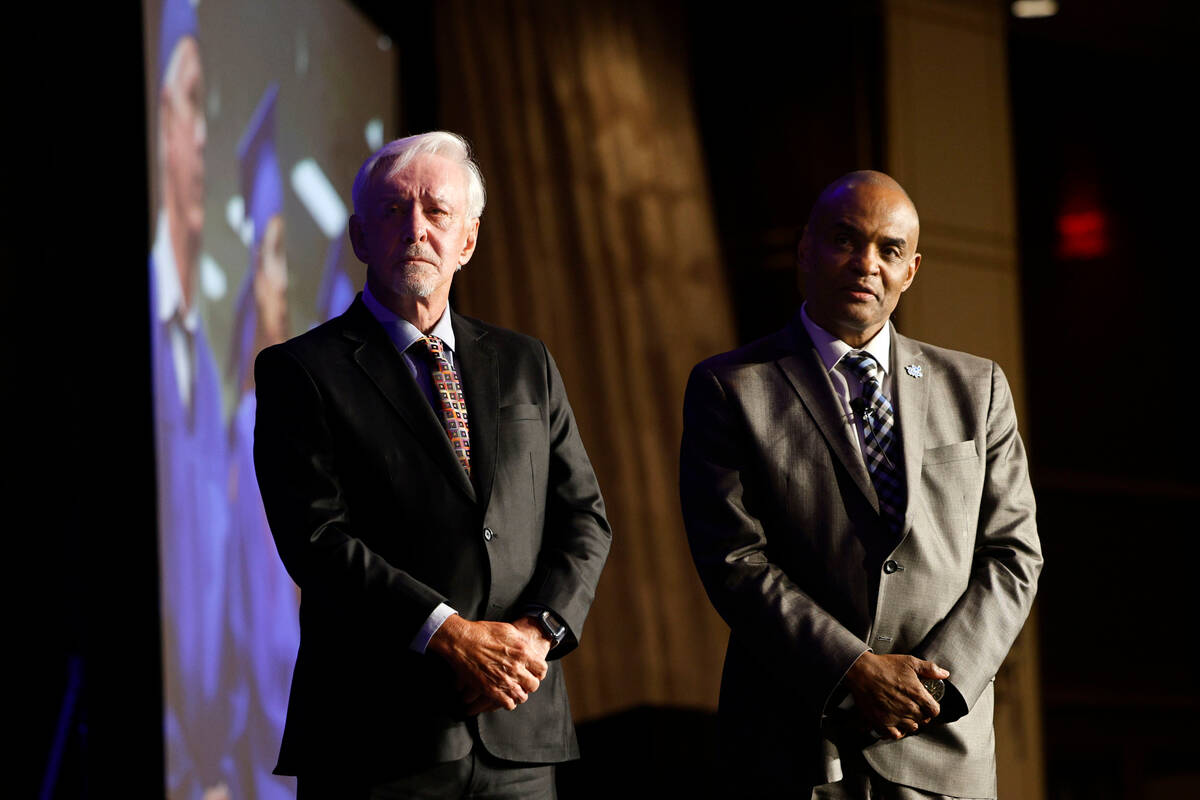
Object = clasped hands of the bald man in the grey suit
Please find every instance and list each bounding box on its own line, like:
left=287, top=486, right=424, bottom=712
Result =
left=845, top=652, right=950, bottom=739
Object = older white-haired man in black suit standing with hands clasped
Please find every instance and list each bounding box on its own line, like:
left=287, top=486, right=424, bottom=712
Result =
left=254, top=132, right=611, bottom=799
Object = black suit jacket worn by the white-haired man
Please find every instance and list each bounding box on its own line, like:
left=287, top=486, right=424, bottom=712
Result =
left=254, top=297, right=611, bottom=780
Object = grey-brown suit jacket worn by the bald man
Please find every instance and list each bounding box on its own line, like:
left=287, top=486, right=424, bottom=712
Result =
left=680, top=317, right=1042, bottom=798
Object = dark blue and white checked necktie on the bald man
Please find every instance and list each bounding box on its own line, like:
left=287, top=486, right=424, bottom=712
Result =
left=841, top=353, right=906, bottom=536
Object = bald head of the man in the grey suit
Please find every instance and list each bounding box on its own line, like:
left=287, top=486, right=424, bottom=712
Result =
left=797, top=169, right=920, bottom=348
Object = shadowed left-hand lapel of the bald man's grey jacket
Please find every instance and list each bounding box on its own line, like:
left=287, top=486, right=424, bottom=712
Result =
left=778, top=317, right=880, bottom=513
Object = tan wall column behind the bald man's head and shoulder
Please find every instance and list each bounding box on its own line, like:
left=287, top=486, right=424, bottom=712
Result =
left=884, top=0, right=1045, bottom=800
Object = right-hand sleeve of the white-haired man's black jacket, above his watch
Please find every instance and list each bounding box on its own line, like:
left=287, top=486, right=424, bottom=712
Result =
left=523, top=345, right=612, bottom=658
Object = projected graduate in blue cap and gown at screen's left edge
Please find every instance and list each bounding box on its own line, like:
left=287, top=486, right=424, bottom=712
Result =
left=150, top=0, right=240, bottom=800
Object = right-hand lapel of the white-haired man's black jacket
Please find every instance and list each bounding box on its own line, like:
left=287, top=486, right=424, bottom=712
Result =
left=450, top=312, right=500, bottom=509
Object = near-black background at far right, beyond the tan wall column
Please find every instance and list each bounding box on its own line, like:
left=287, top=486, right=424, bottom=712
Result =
left=1009, top=2, right=1200, bottom=800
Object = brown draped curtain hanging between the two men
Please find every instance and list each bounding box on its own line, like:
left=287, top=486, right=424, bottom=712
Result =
left=434, top=0, right=734, bottom=720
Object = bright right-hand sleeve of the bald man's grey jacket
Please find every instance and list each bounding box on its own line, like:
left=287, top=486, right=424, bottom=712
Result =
left=919, top=365, right=1042, bottom=722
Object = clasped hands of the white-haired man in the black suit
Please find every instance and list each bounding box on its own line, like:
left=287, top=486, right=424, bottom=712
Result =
left=428, top=614, right=550, bottom=716
